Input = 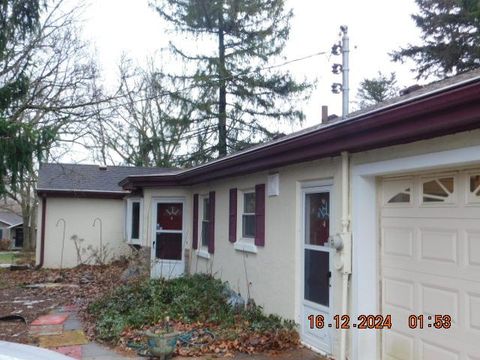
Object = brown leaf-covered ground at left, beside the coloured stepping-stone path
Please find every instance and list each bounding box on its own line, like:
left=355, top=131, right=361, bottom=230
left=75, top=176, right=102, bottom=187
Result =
left=0, top=262, right=127, bottom=344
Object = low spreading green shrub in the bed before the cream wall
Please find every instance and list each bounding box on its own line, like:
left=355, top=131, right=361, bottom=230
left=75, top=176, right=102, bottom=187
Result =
left=88, top=274, right=295, bottom=342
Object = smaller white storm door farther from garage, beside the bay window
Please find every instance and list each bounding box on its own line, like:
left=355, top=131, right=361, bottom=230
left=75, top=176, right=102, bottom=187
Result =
left=151, top=199, right=185, bottom=279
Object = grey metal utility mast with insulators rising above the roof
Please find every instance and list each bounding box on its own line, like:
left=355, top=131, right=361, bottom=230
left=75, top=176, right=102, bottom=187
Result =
left=332, top=25, right=350, bottom=119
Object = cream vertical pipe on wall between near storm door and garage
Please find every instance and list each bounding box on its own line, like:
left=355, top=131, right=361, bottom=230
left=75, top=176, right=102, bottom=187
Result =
left=337, top=151, right=352, bottom=360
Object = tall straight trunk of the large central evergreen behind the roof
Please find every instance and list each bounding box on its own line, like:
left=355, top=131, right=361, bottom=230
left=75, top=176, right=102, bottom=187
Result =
left=218, top=11, right=227, bottom=157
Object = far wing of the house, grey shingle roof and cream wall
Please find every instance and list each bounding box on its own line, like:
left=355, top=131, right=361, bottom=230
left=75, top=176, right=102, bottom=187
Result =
left=36, top=164, right=178, bottom=268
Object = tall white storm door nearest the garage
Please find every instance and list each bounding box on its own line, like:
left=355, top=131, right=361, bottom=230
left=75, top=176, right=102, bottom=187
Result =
left=300, top=187, right=332, bottom=354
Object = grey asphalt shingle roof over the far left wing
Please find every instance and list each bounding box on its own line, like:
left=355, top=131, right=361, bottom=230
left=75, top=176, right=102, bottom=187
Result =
left=37, top=163, right=178, bottom=192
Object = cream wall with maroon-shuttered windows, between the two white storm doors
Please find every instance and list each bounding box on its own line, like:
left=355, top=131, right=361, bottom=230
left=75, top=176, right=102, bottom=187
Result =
left=144, top=158, right=341, bottom=358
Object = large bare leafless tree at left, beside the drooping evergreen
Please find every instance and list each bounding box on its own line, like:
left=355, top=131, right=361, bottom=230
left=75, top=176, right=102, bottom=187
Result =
left=0, top=1, right=107, bottom=249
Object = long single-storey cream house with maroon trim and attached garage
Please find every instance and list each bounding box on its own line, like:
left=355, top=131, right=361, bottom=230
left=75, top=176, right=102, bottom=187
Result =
left=37, top=71, right=480, bottom=360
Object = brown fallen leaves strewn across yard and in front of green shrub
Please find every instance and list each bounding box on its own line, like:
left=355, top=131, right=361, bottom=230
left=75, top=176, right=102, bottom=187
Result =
left=0, top=262, right=299, bottom=357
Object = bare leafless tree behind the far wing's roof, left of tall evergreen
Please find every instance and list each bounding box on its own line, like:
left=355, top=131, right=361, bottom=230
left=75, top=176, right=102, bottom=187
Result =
left=89, top=57, right=192, bottom=167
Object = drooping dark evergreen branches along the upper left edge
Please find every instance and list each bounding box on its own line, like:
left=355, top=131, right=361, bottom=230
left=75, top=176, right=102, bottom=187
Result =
left=0, top=0, right=54, bottom=193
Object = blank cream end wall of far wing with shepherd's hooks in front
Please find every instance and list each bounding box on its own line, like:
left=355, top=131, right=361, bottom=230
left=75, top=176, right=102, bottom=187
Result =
left=36, top=198, right=129, bottom=268
